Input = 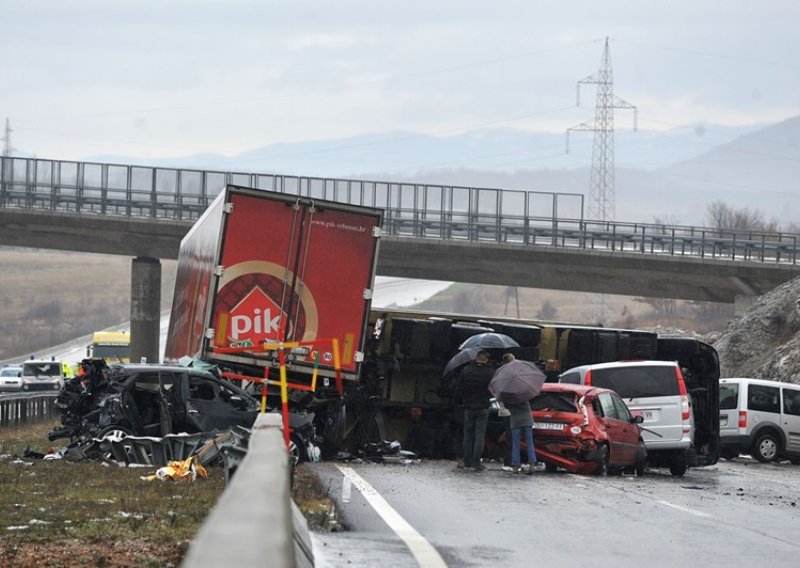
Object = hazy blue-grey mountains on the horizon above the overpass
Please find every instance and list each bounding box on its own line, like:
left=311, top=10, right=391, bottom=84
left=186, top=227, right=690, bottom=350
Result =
left=89, top=117, right=800, bottom=227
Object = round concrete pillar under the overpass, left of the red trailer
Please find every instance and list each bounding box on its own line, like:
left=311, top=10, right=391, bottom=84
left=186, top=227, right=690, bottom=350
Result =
left=131, top=257, right=161, bottom=363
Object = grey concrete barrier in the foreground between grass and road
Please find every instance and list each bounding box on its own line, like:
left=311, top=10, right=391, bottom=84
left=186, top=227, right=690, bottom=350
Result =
left=181, top=413, right=314, bottom=568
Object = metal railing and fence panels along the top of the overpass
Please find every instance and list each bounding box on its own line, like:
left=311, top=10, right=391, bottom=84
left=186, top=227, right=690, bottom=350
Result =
left=0, top=153, right=800, bottom=265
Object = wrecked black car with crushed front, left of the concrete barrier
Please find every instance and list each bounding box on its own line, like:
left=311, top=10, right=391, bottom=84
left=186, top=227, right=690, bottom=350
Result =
left=48, top=364, right=259, bottom=442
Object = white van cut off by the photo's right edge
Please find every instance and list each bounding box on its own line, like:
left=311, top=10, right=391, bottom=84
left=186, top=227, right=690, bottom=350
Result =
left=719, top=378, right=800, bottom=464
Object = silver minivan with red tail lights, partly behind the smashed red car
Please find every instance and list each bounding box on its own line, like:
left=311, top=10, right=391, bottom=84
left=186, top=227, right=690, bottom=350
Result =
left=558, top=360, right=693, bottom=475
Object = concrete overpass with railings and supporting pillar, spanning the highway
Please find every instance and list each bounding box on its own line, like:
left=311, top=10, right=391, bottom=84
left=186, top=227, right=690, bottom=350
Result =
left=0, top=157, right=800, bottom=354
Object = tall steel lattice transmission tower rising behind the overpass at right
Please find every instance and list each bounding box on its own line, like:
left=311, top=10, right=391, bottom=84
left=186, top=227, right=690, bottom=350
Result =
left=567, top=37, right=637, bottom=221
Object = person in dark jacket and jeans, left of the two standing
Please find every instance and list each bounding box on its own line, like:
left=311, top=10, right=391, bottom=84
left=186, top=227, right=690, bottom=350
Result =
left=459, top=350, right=494, bottom=471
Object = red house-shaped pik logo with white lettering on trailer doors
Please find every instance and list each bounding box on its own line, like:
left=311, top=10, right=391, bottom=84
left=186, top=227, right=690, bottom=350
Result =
left=229, top=286, right=286, bottom=344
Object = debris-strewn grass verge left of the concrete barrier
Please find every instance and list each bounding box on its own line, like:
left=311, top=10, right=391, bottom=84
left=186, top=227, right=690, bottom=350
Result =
left=0, top=422, right=225, bottom=567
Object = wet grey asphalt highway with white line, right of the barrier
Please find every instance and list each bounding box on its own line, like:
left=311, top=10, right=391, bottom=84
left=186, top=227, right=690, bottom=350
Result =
left=306, top=457, right=800, bottom=568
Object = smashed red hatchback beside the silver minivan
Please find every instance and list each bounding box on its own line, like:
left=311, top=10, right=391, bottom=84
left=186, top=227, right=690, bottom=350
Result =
left=531, top=383, right=647, bottom=475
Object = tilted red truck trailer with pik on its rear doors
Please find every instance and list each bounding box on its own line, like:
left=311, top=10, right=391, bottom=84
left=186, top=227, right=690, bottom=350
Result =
left=165, top=185, right=382, bottom=386
